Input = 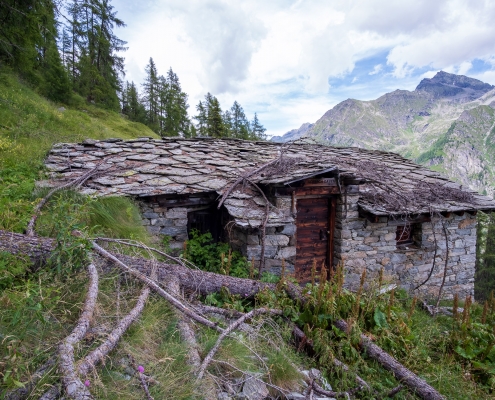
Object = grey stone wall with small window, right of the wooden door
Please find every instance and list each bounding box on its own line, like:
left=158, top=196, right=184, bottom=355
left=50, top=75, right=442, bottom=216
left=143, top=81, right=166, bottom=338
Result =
left=335, top=192, right=476, bottom=298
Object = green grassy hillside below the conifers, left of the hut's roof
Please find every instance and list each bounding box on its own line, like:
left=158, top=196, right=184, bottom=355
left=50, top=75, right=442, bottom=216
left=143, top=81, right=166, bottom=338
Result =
left=0, top=69, right=157, bottom=232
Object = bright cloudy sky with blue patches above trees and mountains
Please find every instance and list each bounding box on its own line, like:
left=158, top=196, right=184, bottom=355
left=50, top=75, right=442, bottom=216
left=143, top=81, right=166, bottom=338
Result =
left=112, top=0, right=495, bottom=135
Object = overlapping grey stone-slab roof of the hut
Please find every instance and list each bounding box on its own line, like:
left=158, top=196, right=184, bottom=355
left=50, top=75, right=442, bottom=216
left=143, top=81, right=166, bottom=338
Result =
left=45, top=138, right=495, bottom=226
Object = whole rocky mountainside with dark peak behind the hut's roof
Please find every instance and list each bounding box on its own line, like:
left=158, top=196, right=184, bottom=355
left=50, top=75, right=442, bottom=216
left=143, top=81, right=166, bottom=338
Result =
left=272, top=71, right=495, bottom=196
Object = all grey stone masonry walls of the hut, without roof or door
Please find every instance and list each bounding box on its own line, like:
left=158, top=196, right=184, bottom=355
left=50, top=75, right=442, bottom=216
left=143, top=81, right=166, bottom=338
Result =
left=140, top=191, right=476, bottom=298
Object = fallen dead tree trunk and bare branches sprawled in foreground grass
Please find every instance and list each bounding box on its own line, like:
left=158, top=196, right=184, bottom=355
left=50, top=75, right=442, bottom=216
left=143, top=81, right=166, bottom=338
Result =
left=0, top=231, right=443, bottom=400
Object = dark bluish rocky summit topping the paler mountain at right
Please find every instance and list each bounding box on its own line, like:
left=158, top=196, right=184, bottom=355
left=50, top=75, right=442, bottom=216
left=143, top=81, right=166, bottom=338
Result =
left=416, top=71, right=495, bottom=101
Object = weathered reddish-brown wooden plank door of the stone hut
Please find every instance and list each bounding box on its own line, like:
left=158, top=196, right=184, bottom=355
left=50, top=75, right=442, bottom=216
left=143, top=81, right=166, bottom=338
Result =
left=295, top=197, right=334, bottom=283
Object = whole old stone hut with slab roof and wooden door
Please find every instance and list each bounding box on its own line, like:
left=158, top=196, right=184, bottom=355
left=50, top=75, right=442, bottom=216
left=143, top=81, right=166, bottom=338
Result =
left=46, top=138, right=495, bottom=296
